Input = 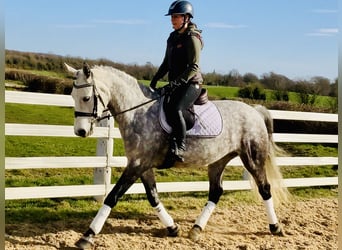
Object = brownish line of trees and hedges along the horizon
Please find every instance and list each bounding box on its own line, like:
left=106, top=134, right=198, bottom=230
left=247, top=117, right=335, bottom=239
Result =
left=5, top=50, right=338, bottom=99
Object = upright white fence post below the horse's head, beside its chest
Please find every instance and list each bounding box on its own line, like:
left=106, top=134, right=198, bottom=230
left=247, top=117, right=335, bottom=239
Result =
left=94, top=111, right=114, bottom=203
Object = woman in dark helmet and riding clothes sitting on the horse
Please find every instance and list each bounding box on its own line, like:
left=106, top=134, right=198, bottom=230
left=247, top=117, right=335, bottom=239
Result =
left=150, top=0, right=203, bottom=168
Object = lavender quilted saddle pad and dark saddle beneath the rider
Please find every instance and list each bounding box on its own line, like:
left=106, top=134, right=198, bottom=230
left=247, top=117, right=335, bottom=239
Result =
left=159, top=88, right=223, bottom=137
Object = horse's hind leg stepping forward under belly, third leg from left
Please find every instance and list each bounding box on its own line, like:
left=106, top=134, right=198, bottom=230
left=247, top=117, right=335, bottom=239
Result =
left=189, top=153, right=236, bottom=241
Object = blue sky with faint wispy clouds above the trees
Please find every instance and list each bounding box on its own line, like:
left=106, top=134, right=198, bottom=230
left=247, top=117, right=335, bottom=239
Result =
left=5, top=0, right=338, bottom=81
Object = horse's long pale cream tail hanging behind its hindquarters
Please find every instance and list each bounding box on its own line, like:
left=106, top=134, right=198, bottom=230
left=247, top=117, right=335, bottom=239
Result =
left=254, top=105, right=290, bottom=204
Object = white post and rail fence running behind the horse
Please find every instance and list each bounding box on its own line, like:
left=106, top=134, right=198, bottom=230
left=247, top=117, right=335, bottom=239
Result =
left=5, top=91, right=338, bottom=200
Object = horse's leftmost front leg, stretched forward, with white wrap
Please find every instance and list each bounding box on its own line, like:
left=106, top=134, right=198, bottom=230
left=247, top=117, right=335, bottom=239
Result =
left=75, top=165, right=141, bottom=249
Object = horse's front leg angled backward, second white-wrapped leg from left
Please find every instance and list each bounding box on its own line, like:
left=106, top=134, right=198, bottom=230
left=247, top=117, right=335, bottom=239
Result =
left=141, top=168, right=179, bottom=237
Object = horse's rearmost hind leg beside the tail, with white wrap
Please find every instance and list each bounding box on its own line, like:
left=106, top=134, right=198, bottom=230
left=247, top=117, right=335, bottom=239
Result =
left=240, top=145, right=284, bottom=235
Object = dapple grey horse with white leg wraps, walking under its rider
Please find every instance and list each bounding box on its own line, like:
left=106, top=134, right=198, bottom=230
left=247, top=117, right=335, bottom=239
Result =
left=66, top=64, right=287, bottom=249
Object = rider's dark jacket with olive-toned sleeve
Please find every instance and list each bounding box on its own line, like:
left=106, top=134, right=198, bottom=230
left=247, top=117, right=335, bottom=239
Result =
left=151, top=23, right=203, bottom=87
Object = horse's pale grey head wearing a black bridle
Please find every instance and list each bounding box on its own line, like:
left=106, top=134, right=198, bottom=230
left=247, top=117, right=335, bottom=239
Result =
left=65, top=63, right=105, bottom=137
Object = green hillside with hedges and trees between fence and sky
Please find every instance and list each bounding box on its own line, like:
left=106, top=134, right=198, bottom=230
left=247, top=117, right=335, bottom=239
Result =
left=5, top=50, right=337, bottom=113
